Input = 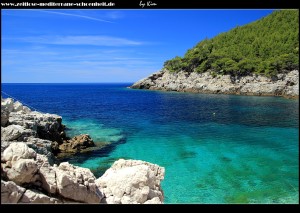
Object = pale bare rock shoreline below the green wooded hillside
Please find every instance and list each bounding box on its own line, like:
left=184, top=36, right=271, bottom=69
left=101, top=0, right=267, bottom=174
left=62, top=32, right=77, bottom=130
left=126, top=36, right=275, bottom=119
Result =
left=130, top=69, right=299, bottom=99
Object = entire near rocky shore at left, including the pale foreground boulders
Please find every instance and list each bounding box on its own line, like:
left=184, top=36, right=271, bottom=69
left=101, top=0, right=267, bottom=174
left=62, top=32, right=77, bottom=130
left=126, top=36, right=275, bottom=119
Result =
left=1, top=98, right=165, bottom=204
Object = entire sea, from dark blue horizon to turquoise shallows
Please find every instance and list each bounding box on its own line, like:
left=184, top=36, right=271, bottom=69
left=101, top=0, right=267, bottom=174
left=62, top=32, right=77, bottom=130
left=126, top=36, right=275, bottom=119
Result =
left=2, top=84, right=299, bottom=203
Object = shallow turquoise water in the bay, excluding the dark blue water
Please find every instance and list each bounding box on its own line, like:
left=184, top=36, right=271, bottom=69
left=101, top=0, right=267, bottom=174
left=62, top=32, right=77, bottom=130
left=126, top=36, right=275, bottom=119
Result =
left=65, top=118, right=299, bottom=203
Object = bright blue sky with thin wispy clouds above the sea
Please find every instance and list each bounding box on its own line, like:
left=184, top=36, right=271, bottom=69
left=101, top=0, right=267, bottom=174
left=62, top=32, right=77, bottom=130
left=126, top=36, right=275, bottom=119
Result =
left=1, top=9, right=272, bottom=83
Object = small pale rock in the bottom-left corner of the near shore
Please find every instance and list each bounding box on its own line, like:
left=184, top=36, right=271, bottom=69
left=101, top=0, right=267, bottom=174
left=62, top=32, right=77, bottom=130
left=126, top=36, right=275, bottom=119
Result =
left=1, top=180, right=26, bottom=203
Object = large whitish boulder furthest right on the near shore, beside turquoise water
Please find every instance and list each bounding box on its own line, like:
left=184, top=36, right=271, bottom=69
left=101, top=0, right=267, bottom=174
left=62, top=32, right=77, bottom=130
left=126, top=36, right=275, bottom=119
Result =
left=96, top=159, right=165, bottom=204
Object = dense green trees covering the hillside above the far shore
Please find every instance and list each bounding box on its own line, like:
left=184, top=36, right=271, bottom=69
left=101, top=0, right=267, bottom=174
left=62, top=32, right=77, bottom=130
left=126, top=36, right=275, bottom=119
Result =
left=164, top=10, right=299, bottom=76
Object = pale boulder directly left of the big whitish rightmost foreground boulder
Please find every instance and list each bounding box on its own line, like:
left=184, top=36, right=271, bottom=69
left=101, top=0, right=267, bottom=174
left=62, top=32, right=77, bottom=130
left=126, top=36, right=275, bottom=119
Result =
left=54, top=162, right=103, bottom=203
